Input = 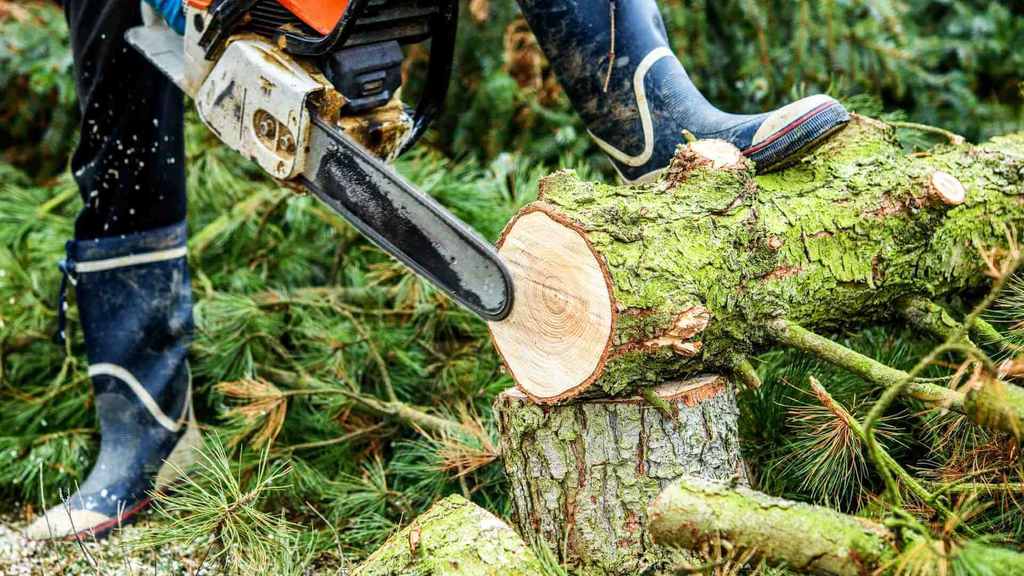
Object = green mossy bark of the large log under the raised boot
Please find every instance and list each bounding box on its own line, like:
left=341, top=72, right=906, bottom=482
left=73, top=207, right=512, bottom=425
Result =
left=497, top=117, right=1024, bottom=400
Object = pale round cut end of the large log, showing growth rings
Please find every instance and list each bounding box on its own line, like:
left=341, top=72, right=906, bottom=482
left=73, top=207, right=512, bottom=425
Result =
left=490, top=207, right=614, bottom=403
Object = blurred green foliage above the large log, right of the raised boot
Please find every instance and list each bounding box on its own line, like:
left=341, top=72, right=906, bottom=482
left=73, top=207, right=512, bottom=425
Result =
left=663, top=0, right=1024, bottom=139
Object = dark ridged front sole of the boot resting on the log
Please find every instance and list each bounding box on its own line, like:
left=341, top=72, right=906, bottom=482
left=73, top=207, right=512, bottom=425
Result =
left=743, top=102, right=850, bottom=173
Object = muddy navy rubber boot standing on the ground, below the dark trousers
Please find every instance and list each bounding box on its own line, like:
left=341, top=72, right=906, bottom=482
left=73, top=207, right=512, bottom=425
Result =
left=27, top=222, right=201, bottom=539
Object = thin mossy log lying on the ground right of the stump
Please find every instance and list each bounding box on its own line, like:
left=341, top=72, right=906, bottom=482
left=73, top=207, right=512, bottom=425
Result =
left=648, top=479, right=1024, bottom=576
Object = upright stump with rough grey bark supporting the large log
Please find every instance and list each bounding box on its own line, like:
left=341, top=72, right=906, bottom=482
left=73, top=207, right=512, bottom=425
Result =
left=495, top=376, right=745, bottom=575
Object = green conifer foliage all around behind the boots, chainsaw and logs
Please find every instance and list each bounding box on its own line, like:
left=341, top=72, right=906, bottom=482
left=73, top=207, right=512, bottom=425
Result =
left=0, top=0, right=1024, bottom=573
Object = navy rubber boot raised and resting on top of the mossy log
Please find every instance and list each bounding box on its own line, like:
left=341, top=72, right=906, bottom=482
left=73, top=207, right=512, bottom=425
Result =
left=519, top=0, right=849, bottom=181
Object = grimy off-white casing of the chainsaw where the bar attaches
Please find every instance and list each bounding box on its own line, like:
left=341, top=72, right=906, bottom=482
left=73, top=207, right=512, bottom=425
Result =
left=183, top=1, right=413, bottom=180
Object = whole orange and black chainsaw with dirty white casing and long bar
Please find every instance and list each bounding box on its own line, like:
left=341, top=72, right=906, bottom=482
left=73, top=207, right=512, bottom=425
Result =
left=126, top=0, right=513, bottom=321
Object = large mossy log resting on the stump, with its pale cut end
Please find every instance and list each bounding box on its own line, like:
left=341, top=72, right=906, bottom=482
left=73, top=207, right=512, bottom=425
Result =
left=490, top=117, right=1024, bottom=403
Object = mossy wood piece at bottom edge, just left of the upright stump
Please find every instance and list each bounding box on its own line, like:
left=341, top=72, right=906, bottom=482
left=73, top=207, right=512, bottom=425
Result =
left=352, top=496, right=544, bottom=576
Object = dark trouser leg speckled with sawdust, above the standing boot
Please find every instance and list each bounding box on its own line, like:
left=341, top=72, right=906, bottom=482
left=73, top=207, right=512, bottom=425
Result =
left=63, top=0, right=185, bottom=240
